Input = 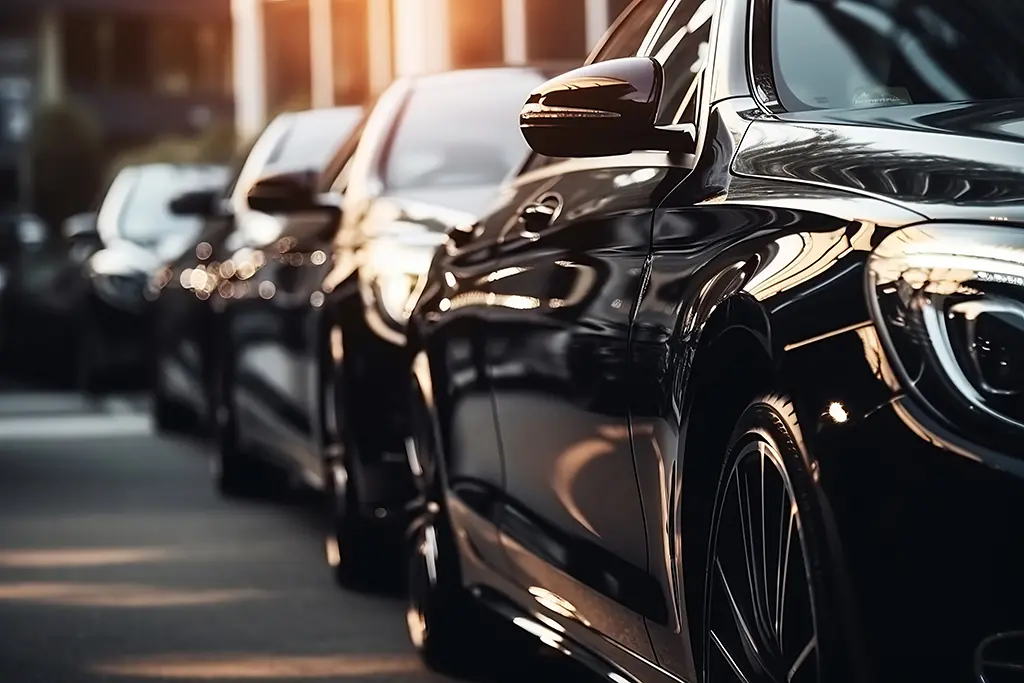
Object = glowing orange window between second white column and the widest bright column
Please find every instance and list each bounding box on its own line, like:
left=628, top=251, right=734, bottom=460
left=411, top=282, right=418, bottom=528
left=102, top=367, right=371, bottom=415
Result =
left=331, top=0, right=368, bottom=104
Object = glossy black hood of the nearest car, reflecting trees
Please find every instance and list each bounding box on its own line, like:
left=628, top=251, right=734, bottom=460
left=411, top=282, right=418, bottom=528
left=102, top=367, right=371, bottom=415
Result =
left=733, top=100, right=1024, bottom=221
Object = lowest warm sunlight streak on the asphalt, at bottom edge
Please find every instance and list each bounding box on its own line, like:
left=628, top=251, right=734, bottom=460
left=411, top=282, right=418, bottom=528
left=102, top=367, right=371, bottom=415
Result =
left=92, top=654, right=423, bottom=681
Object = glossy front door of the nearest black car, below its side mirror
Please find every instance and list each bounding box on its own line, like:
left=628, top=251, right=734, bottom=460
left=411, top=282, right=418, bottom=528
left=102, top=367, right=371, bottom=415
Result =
left=486, top=2, right=688, bottom=657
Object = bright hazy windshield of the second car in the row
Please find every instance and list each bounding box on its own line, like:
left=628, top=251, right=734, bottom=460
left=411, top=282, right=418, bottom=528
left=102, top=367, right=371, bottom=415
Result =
left=381, top=70, right=545, bottom=193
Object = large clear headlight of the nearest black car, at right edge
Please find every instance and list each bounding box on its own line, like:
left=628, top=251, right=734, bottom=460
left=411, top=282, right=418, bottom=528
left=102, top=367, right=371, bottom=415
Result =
left=866, top=224, right=1024, bottom=432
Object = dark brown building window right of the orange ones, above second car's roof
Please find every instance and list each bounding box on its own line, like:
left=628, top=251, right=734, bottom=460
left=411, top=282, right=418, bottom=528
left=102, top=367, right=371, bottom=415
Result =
left=526, top=0, right=590, bottom=61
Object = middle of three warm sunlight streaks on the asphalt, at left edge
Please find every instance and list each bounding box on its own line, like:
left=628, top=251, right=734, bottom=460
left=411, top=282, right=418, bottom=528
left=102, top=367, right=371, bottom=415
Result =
left=0, top=583, right=268, bottom=607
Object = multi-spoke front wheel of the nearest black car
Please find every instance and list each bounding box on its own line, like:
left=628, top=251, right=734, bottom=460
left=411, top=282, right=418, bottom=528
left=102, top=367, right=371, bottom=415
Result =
left=701, top=395, right=850, bottom=683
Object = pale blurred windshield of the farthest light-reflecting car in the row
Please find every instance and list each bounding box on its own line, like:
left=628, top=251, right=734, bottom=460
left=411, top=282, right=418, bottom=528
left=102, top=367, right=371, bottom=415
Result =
left=117, top=166, right=226, bottom=245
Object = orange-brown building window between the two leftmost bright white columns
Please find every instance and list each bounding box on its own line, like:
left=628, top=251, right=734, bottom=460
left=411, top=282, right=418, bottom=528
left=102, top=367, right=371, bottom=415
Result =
left=263, top=0, right=312, bottom=113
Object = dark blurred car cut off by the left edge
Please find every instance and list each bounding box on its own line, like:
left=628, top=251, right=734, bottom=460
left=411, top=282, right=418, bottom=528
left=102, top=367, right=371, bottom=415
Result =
left=0, top=211, right=99, bottom=384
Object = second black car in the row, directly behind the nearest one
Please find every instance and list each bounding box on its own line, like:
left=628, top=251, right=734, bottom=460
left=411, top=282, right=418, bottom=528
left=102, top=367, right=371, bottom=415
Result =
left=216, top=67, right=557, bottom=585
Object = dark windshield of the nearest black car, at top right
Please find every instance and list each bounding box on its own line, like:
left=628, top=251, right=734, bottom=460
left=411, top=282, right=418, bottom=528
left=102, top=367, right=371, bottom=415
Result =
left=772, top=0, right=1024, bottom=111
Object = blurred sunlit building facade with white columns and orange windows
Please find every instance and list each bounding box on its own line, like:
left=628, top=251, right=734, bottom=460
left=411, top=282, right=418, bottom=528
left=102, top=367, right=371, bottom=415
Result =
left=231, top=0, right=631, bottom=137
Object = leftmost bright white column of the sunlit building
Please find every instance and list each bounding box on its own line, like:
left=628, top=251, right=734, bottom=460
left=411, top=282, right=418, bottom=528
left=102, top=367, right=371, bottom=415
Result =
left=231, top=0, right=266, bottom=140
